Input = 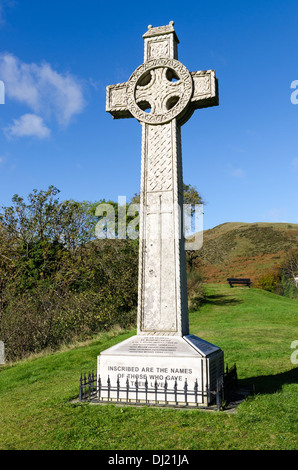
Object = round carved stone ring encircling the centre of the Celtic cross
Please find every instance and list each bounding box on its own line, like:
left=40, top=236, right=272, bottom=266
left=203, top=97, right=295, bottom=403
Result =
left=126, top=58, right=193, bottom=124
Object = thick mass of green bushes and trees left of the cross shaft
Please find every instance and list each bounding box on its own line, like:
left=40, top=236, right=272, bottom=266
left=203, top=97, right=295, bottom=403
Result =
left=0, top=187, right=138, bottom=360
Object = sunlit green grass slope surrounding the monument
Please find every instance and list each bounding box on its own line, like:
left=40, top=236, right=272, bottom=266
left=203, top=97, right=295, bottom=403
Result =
left=0, top=285, right=298, bottom=450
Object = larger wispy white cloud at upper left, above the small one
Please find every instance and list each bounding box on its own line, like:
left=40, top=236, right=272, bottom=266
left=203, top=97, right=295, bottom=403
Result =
left=0, top=53, right=85, bottom=134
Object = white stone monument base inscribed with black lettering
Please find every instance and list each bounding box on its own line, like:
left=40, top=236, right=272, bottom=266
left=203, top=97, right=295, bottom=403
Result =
left=97, top=335, right=224, bottom=406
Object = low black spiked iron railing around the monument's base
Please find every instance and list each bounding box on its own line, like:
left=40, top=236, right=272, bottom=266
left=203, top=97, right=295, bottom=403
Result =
left=79, top=364, right=237, bottom=410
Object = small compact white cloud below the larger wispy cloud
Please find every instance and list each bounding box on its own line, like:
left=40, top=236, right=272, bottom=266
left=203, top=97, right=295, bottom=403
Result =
left=4, top=114, right=51, bottom=139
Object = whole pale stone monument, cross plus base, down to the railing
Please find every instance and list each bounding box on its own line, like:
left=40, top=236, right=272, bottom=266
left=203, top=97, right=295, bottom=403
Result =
left=98, top=21, right=223, bottom=404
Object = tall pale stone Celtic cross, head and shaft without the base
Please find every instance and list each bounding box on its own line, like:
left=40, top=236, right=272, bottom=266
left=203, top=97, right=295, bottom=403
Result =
left=106, top=21, right=218, bottom=336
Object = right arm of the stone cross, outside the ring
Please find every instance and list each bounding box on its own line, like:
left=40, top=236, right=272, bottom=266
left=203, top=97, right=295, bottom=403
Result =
left=190, top=70, right=218, bottom=109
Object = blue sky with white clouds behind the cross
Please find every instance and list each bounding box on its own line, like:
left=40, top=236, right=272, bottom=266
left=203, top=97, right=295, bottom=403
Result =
left=0, top=0, right=298, bottom=229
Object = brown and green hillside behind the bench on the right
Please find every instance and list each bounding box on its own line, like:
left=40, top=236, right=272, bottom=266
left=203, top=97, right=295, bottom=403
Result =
left=196, top=222, right=298, bottom=282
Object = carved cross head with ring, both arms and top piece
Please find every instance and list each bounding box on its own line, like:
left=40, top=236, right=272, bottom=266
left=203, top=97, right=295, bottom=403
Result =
left=106, top=21, right=218, bottom=125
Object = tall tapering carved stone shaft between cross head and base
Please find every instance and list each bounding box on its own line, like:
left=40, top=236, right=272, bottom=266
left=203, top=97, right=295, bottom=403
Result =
left=138, top=119, right=188, bottom=336
